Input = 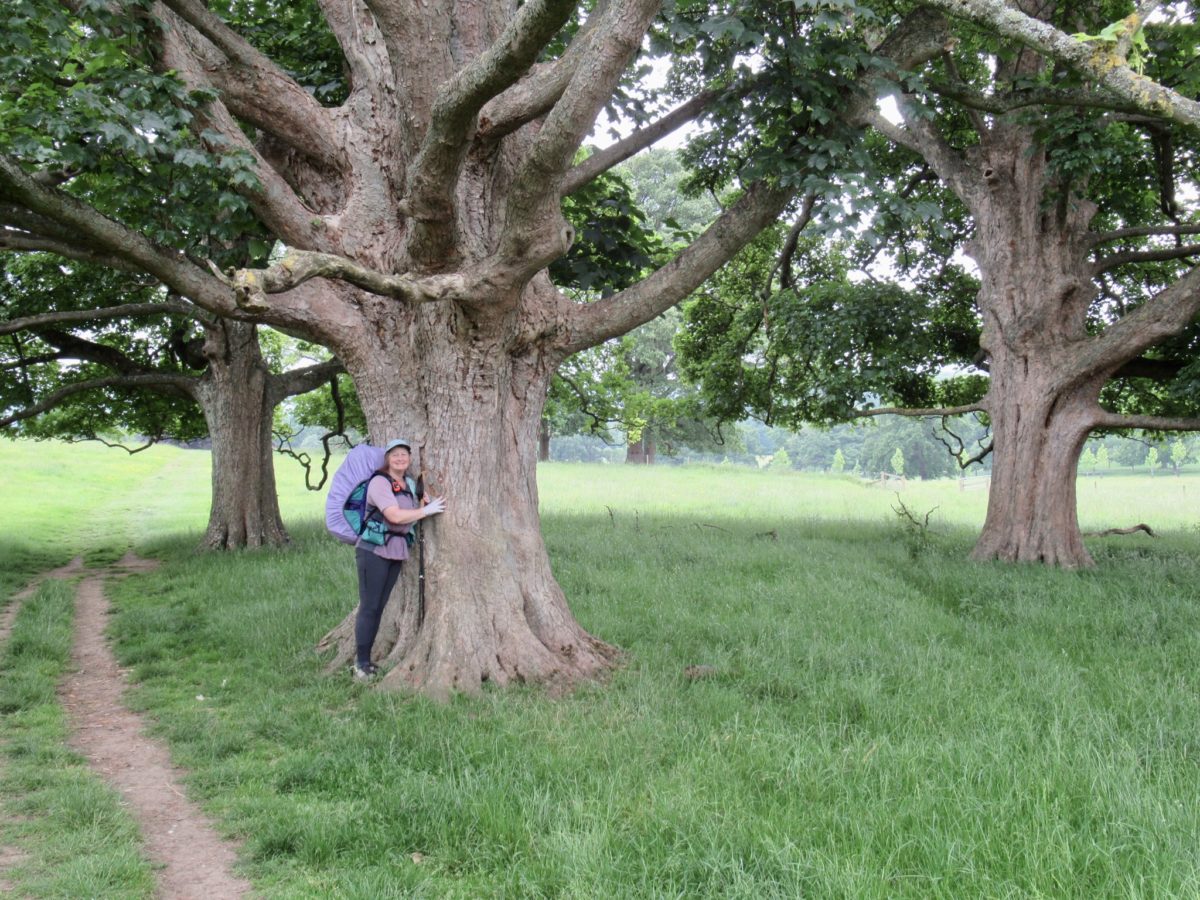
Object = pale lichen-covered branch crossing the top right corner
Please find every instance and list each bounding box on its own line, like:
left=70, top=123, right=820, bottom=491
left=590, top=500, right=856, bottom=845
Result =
left=926, top=0, right=1200, bottom=127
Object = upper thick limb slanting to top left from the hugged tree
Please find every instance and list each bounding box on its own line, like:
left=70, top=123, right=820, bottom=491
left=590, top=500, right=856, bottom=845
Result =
left=162, top=0, right=342, bottom=167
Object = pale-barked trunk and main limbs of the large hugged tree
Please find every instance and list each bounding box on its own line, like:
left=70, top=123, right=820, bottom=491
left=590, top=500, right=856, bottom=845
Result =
left=0, top=0, right=946, bottom=697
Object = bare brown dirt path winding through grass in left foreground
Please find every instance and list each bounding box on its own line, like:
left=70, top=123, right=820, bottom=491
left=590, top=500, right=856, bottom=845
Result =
left=61, top=554, right=250, bottom=900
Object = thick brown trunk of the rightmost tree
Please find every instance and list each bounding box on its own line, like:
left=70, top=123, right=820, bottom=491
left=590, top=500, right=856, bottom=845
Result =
left=964, top=126, right=1104, bottom=568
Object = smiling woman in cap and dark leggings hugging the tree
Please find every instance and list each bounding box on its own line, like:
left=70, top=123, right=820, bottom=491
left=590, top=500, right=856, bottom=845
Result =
left=354, top=440, right=445, bottom=680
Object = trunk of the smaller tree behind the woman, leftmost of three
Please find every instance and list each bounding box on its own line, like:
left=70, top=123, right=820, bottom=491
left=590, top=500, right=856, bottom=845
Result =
left=196, top=320, right=288, bottom=550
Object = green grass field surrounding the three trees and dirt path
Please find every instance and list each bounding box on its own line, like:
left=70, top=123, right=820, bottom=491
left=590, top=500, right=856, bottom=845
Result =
left=0, top=443, right=1200, bottom=900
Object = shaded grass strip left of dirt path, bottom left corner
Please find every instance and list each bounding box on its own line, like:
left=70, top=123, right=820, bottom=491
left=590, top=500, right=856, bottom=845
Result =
left=0, top=582, right=154, bottom=898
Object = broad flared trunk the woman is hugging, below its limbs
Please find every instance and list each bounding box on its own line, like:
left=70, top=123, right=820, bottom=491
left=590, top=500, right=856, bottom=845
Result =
left=320, top=284, right=617, bottom=697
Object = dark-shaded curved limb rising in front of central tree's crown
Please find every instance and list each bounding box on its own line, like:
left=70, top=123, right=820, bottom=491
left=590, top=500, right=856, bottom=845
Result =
left=401, top=0, right=575, bottom=268
